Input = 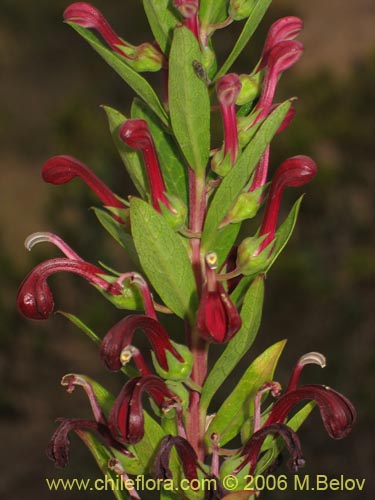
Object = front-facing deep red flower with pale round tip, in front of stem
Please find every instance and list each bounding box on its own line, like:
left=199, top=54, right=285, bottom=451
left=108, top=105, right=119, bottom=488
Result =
left=197, top=252, right=242, bottom=343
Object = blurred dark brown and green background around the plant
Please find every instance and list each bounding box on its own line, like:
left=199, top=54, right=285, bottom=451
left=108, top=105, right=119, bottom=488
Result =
left=0, top=0, right=375, bottom=500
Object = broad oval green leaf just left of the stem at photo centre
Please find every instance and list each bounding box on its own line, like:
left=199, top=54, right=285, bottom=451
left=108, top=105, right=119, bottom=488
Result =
left=130, top=198, right=197, bottom=318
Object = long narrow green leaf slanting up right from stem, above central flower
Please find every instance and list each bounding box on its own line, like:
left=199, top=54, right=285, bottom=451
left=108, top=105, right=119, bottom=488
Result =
left=202, top=101, right=290, bottom=258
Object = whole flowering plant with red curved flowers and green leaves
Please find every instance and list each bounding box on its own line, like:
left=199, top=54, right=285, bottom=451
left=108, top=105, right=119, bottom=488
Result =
left=17, top=0, right=356, bottom=500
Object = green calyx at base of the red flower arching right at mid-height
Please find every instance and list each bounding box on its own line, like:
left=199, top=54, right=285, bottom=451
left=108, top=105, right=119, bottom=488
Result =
left=237, top=235, right=273, bottom=276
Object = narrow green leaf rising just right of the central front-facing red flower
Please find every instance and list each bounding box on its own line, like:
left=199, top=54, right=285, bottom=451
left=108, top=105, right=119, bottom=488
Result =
left=201, top=276, right=264, bottom=410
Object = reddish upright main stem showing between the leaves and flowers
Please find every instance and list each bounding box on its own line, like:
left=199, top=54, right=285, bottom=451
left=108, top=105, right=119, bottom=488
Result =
left=186, top=169, right=207, bottom=460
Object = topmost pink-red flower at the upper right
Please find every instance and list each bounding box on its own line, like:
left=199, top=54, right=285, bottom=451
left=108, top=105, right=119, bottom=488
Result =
left=258, top=16, right=303, bottom=71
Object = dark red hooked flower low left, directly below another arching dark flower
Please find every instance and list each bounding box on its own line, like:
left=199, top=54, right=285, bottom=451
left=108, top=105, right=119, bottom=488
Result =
left=108, top=375, right=179, bottom=444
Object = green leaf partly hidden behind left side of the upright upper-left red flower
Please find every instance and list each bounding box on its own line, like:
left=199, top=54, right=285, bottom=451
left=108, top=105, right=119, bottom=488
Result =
left=103, top=106, right=149, bottom=198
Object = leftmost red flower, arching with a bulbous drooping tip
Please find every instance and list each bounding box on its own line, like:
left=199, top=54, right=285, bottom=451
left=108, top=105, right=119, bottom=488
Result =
left=17, top=258, right=121, bottom=319
